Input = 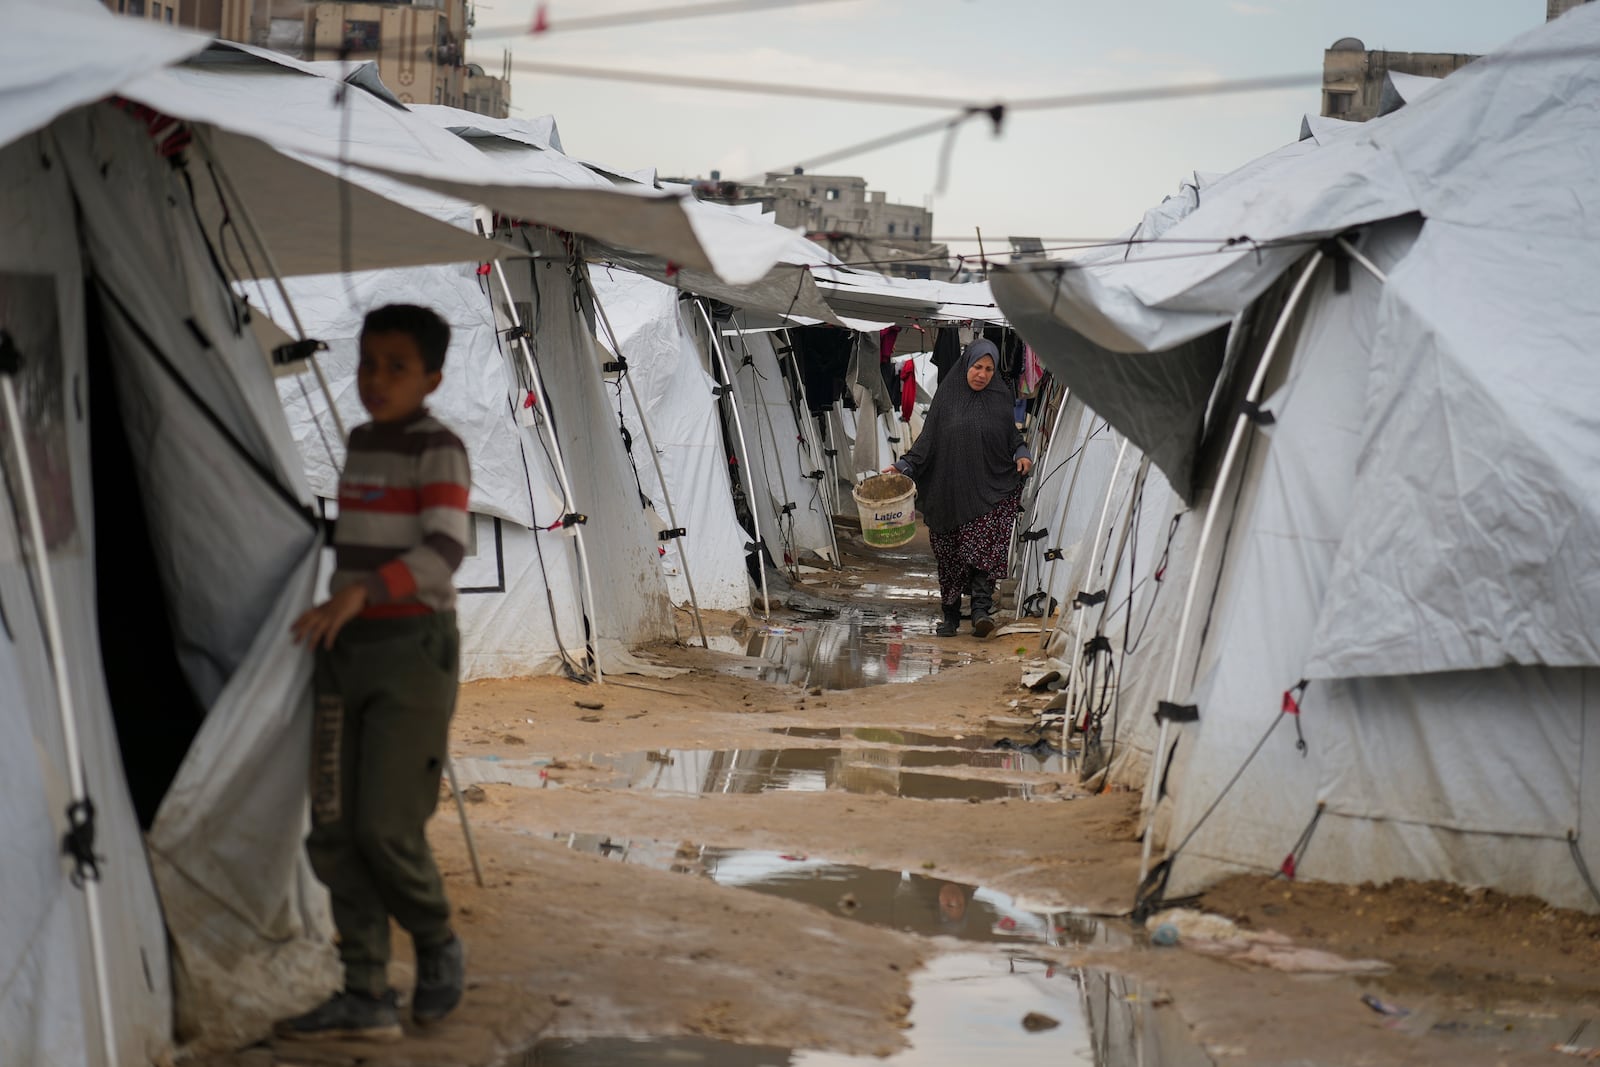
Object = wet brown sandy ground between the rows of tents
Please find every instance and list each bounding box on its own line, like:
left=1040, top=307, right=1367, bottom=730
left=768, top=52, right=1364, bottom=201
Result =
left=208, top=531, right=1600, bottom=1067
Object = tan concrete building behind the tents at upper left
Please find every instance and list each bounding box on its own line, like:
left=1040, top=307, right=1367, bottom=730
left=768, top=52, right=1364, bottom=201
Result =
left=104, top=0, right=510, bottom=118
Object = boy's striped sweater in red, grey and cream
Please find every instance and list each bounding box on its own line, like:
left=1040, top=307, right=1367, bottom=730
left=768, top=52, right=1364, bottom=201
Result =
left=330, top=410, right=472, bottom=617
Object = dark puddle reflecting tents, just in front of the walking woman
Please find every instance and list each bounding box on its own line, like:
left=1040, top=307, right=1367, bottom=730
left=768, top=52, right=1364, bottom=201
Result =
left=728, top=611, right=973, bottom=689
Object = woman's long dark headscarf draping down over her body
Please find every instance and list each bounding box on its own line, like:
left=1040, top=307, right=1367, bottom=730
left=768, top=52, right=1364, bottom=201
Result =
left=898, top=338, right=1027, bottom=533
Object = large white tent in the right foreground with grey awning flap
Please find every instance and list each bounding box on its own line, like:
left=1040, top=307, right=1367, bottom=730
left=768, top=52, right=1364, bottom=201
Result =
left=995, top=10, right=1600, bottom=909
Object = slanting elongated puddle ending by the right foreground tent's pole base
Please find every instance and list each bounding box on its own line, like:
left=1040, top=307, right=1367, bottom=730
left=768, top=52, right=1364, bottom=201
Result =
left=552, top=833, right=1131, bottom=947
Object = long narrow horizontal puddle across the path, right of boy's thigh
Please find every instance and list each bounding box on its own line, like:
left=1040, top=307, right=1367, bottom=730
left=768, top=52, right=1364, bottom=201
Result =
left=456, top=742, right=1067, bottom=800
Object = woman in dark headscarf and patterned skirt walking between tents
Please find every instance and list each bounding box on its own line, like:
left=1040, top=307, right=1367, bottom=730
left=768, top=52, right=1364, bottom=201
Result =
left=893, top=339, right=1034, bottom=637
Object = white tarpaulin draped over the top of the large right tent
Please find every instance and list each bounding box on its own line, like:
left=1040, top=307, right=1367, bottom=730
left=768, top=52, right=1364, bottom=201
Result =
left=995, top=8, right=1600, bottom=677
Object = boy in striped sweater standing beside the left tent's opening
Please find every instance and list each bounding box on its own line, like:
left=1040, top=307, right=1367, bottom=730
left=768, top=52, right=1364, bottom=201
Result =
left=277, top=304, right=470, bottom=1040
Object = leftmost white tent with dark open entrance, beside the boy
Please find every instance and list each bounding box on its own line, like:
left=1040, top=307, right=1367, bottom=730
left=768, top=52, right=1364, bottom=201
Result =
left=0, top=6, right=361, bottom=1064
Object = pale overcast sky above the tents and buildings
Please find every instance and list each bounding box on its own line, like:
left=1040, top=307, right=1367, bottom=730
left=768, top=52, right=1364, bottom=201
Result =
left=472, top=0, right=1544, bottom=243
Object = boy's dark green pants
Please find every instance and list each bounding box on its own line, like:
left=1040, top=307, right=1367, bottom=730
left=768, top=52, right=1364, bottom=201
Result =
left=306, top=611, right=461, bottom=995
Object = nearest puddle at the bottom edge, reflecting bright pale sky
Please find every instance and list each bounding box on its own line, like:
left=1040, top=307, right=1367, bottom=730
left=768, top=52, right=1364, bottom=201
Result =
left=520, top=952, right=1211, bottom=1067
